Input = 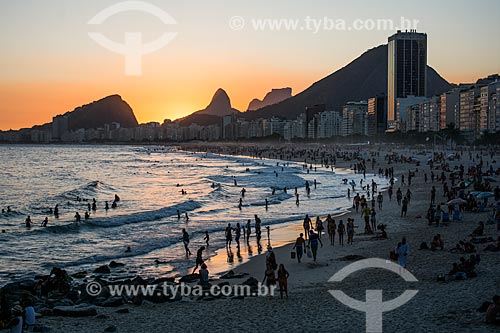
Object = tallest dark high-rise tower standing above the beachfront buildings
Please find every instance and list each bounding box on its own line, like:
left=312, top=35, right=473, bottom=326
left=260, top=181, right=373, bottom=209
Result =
left=387, top=30, right=427, bottom=129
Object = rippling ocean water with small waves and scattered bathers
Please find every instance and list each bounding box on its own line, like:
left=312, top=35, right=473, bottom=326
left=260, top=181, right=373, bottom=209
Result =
left=0, top=145, right=387, bottom=285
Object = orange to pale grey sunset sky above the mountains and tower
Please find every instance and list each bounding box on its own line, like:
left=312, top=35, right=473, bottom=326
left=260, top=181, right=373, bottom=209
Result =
left=0, top=0, right=500, bottom=130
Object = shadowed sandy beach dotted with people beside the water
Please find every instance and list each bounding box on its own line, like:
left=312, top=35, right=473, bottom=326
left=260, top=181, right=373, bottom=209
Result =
left=6, top=143, right=500, bottom=333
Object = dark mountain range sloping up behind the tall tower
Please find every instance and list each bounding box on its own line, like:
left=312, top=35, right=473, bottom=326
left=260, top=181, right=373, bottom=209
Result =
left=180, top=44, right=453, bottom=125
